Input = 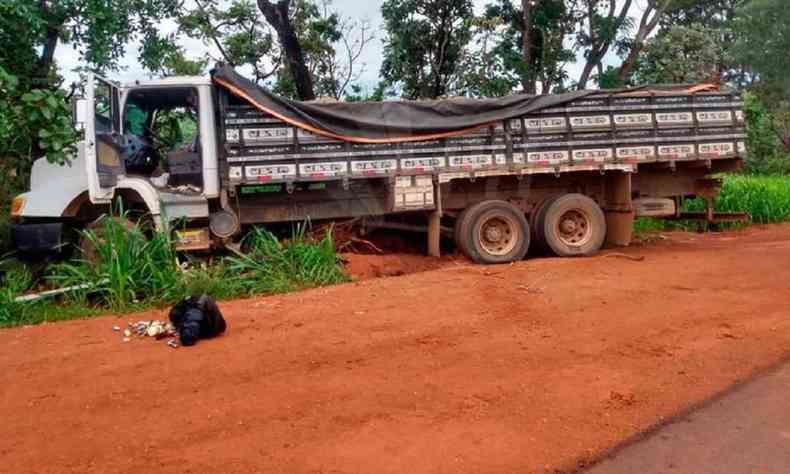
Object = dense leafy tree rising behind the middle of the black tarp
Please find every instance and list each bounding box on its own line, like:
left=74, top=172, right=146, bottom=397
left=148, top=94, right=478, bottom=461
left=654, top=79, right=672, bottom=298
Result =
left=381, top=0, right=473, bottom=99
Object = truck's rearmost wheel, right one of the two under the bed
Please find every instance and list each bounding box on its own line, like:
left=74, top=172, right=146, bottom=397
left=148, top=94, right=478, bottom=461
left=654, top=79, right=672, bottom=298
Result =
left=538, top=194, right=606, bottom=257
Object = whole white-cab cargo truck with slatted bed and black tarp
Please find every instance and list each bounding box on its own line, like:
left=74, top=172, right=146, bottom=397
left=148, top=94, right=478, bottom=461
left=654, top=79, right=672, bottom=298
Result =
left=12, top=64, right=746, bottom=264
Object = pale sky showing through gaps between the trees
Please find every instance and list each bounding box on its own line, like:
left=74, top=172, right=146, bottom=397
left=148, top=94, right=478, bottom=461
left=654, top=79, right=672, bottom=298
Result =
left=56, top=0, right=640, bottom=87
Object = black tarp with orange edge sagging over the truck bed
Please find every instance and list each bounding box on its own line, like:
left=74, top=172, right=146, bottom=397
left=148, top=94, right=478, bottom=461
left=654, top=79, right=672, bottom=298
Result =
left=211, top=65, right=594, bottom=143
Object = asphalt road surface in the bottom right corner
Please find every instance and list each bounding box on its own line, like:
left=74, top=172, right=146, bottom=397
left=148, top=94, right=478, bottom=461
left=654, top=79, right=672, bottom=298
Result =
left=585, top=363, right=790, bottom=474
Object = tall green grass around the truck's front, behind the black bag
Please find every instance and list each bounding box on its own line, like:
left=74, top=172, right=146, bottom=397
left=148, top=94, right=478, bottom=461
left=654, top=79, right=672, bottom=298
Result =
left=0, top=218, right=348, bottom=327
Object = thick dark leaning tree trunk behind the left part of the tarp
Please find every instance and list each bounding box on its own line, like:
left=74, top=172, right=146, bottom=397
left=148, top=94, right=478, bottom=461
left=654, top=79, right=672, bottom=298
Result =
left=258, top=0, right=315, bottom=100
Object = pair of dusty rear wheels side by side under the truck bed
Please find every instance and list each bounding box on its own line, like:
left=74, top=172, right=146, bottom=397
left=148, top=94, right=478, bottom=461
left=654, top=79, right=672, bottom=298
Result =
left=455, top=194, right=606, bottom=264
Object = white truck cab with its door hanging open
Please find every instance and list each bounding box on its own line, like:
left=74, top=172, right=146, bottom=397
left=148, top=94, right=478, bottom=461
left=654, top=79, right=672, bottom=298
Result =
left=12, top=74, right=220, bottom=252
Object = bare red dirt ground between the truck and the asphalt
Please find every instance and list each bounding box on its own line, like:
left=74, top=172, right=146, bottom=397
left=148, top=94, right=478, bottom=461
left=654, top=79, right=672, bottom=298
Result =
left=0, top=226, right=790, bottom=473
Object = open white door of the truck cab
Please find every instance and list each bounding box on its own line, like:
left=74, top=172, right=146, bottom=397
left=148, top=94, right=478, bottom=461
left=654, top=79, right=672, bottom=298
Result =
left=85, top=73, right=124, bottom=203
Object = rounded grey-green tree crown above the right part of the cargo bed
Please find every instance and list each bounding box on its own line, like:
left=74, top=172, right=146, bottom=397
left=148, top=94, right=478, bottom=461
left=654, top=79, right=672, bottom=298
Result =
left=633, top=25, right=728, bottom=84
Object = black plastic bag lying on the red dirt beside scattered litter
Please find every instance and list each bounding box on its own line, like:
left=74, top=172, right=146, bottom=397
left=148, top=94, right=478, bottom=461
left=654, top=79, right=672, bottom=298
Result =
left=170, top=295, right=227, bottom=346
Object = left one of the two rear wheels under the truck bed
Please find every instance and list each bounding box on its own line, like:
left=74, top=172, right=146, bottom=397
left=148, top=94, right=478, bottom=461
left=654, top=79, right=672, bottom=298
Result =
left=456, top=201, right=530, bottom=264
